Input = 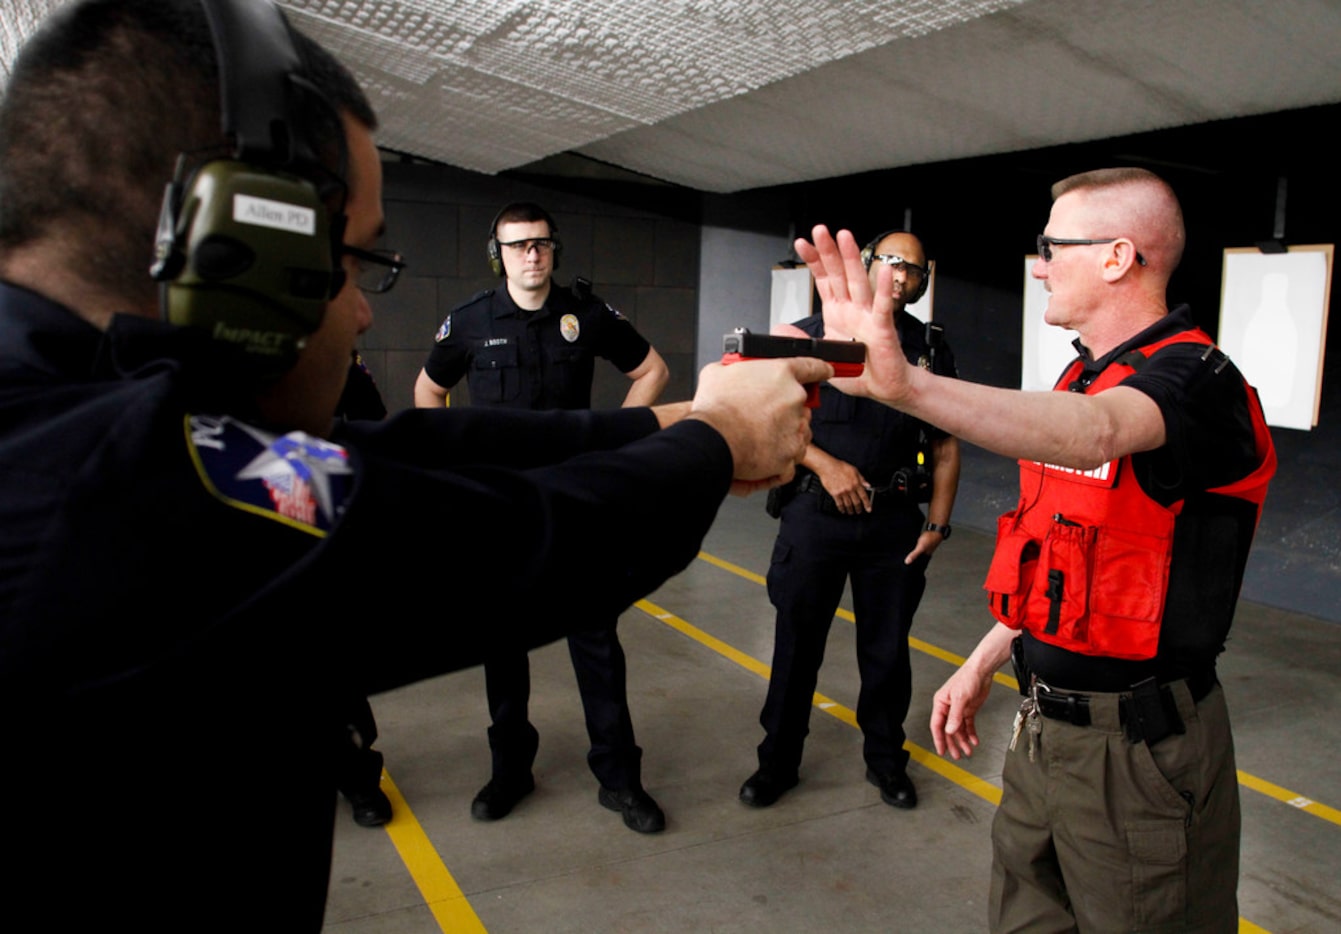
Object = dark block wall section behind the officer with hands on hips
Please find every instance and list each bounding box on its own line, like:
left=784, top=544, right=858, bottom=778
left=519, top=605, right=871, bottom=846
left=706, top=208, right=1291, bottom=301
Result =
left=361, top=161, right=699, bottom=412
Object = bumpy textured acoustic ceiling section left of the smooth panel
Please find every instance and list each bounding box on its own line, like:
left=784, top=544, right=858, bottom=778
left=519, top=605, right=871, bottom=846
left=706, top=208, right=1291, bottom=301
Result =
left=284, top=0, right=1022, bottom=172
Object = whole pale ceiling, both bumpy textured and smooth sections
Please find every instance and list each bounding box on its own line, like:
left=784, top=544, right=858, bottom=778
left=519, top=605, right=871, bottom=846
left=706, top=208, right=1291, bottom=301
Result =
left=0, top=0, right=1341, bottom=192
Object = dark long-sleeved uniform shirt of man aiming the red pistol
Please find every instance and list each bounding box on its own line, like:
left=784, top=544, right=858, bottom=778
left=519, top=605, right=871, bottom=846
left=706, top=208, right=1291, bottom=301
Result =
left=0, top=283, right=731, bottom=931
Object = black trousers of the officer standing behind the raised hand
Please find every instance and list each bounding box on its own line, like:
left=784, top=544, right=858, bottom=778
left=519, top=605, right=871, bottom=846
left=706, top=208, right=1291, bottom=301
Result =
left=759, top=492, right=928, bottom=776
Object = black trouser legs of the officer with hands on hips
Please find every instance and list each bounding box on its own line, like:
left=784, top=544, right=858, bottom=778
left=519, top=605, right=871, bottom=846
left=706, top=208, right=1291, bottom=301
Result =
left=484, top=625, right=642, bottom=790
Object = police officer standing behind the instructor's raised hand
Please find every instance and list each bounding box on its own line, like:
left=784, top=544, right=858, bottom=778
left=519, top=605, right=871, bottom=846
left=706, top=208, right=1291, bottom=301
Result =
left=740, top=231, right=959, bottom=808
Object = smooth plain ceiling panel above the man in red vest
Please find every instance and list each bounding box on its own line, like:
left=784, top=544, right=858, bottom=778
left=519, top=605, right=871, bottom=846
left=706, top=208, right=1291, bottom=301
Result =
left=579, top=0, right=1341, bottom=191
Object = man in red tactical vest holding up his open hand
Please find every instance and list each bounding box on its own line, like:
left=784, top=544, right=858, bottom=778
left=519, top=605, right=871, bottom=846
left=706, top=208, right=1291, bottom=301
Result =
left=798, top=169, right=1275, bottom=931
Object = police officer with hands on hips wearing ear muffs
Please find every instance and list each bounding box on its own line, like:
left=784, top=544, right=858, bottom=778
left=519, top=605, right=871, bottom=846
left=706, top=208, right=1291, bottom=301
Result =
left=414, top=203, right=668, bottom=833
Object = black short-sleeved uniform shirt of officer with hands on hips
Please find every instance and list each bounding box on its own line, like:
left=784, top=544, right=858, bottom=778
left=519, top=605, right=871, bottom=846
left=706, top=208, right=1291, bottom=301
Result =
left=424, top=282, right=652, bottom=409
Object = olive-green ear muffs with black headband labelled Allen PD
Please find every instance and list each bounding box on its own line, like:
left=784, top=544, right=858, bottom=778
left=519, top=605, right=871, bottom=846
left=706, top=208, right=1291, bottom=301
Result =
left=150, top=0, right=347, bottom=381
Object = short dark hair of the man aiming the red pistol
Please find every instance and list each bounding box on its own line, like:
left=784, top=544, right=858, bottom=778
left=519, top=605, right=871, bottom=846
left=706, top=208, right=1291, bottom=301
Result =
left=0, top=0, right=377, bottom=306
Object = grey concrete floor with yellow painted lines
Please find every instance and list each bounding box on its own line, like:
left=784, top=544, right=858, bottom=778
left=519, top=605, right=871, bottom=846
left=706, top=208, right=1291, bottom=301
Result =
left=326, top=497, right=1341, bottom=934
